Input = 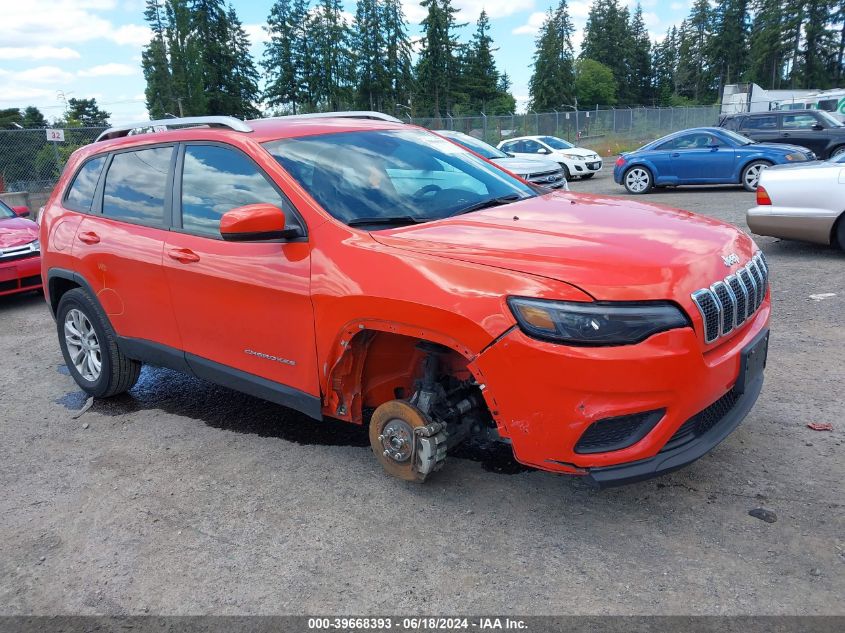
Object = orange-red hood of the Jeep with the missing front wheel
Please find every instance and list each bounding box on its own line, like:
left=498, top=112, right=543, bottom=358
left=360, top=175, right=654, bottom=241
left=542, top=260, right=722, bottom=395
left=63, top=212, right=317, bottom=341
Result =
left=372, top=192, right=754, bottom=306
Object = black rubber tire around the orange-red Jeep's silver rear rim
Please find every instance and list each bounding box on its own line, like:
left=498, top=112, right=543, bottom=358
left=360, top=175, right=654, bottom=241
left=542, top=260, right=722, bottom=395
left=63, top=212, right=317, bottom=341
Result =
left=56, top=288, right=141, bottom=398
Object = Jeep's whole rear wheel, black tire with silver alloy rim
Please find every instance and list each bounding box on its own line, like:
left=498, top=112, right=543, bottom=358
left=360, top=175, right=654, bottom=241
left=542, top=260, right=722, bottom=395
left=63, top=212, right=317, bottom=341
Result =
left=56, top=288, right=141, bottom=398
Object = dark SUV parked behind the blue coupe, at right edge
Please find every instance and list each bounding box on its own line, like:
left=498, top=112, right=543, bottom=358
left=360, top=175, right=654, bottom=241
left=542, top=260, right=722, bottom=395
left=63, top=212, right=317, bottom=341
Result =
left=720, top=110, right=845, bottom=159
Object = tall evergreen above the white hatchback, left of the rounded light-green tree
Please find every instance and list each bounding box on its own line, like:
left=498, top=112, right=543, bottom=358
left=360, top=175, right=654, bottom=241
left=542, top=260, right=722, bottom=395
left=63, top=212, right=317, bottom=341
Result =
left=528, top=0, right=575, bottom=112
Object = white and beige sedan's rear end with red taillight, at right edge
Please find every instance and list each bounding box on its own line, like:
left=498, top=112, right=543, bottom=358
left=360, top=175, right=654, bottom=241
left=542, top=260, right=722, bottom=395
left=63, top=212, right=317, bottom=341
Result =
left=745, top=154, right=845, bottom=250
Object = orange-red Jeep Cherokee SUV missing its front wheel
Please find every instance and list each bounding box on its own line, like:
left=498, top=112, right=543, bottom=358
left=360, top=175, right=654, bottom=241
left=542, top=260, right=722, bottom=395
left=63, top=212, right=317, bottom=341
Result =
left=41, top=113, right=770, bottom=485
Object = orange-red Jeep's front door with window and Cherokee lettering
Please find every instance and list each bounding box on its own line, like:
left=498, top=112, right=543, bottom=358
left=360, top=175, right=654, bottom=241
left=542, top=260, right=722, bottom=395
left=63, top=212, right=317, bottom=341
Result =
left=164, top=143, right=319, bottom=395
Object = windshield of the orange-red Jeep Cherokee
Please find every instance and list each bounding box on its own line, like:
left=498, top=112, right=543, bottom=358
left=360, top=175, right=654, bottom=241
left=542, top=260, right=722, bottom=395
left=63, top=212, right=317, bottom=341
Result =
left=264, top=130, right=536, bottom=225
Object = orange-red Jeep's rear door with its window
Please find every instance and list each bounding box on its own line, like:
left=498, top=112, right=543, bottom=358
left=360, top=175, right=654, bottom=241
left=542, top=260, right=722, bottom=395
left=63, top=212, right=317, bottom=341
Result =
left=71, top=145, right=180, bottom=348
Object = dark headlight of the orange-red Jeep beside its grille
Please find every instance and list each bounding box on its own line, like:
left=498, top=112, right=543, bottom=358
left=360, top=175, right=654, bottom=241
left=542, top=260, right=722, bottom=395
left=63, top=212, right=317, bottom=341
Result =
left=508, top=297, right=690, bottom=346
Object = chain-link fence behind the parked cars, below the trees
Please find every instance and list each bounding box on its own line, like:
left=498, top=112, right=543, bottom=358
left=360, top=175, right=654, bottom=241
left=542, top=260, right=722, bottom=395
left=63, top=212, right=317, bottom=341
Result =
left=0, top=106, right=719, bottom=202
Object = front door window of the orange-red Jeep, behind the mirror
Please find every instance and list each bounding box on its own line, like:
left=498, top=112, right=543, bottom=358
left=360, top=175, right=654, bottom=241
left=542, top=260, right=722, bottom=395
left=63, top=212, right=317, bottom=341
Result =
left=182, top=145, right=284, bottom=235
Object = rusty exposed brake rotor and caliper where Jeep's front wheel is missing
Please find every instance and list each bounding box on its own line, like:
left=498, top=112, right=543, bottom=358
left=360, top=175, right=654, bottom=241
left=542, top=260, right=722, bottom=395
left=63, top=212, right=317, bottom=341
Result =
left=370, top=400, right=446, bottom=482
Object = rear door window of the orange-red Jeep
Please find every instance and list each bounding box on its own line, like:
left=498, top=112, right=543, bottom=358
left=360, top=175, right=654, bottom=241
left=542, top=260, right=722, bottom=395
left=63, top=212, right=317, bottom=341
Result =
left=103, top=147, right=173, bottom=225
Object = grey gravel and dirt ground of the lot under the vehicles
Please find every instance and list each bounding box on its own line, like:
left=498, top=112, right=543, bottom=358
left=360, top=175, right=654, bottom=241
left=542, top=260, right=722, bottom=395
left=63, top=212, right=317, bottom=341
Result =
left=0, top=172, right=845, bottom=615
